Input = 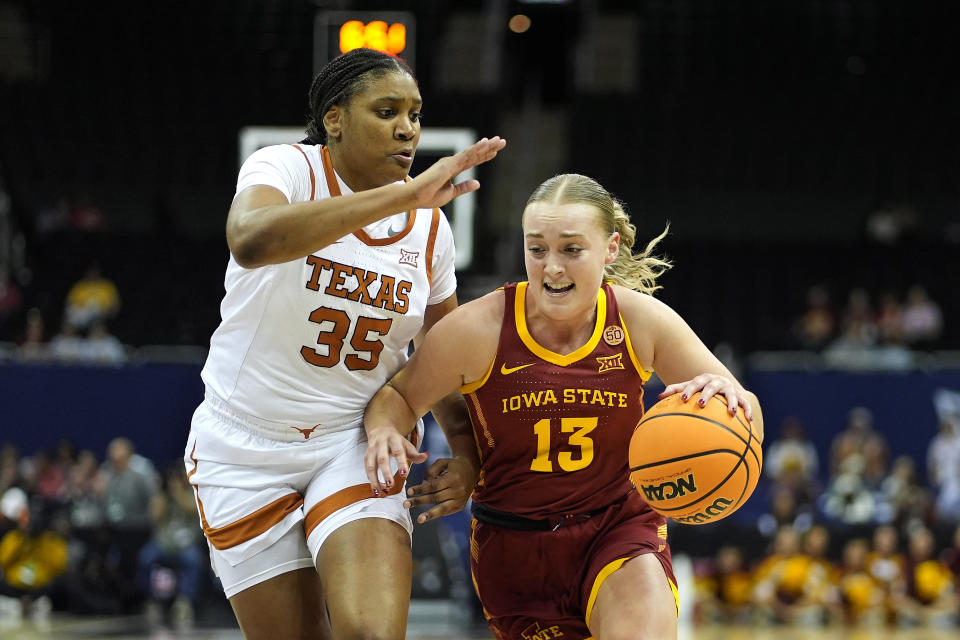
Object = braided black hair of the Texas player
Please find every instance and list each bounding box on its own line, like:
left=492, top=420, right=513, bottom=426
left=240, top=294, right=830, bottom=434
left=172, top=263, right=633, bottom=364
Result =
left=301, top=48, right=417, bottom=144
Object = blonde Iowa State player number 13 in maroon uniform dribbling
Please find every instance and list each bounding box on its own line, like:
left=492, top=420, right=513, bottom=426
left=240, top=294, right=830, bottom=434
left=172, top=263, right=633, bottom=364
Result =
left=365, top=174, right=763, bottom=640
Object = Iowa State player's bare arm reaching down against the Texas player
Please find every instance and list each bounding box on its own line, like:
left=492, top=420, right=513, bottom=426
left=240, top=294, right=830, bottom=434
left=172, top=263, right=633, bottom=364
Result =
left=363, top=291, right=504, bottom=493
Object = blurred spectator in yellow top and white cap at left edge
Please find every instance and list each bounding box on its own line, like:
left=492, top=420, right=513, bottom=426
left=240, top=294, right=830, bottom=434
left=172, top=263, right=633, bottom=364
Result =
left=0, top=487, right=67, bottom=624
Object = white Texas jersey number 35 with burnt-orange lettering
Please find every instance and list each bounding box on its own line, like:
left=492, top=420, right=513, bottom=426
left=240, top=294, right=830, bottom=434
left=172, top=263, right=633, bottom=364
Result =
left=201, top=145, right=456, bottom=437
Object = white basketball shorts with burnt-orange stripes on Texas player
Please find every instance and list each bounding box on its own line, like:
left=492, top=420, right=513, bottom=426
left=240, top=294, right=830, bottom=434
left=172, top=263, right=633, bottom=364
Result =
left=184, top=398, right=423, bottom=598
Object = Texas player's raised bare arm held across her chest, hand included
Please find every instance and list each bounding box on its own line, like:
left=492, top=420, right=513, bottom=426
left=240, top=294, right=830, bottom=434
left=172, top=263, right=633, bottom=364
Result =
left=227, top=137, right=506, bottom=269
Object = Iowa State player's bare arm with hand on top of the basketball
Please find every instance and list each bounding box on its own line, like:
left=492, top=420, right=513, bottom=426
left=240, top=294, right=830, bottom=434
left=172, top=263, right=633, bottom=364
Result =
left=617, top=288, right=763, bottom=441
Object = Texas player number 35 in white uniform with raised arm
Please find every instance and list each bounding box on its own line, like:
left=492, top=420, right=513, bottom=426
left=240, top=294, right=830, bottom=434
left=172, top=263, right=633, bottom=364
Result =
left=185, top=50, right=505, bottom=638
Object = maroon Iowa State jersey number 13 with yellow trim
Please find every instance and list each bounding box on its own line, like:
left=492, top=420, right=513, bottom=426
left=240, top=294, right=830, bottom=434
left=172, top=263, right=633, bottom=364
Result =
left=461, top=282, right=650, bottom=519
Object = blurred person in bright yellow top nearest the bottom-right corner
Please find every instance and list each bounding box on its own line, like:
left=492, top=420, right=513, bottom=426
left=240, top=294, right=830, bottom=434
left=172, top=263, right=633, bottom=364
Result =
left=897, top=527, right=958, bottom=629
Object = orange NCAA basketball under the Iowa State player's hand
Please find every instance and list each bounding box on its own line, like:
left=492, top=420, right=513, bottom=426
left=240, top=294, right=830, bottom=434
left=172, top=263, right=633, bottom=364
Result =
left=630, top=392, right=763, bottom=524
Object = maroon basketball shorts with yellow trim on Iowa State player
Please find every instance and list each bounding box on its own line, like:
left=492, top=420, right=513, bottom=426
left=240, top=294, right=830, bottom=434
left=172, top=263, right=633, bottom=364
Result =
left=470, top=491, right=677, bottom=640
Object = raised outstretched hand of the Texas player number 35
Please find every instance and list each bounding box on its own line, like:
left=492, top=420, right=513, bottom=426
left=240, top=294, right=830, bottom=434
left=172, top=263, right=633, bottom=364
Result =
left=407, top=136, right=507, bottom=209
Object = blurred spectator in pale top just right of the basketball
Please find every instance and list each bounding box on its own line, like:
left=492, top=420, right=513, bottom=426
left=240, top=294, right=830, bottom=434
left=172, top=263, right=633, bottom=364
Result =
left=764, top=416, right=820, bottom=506
